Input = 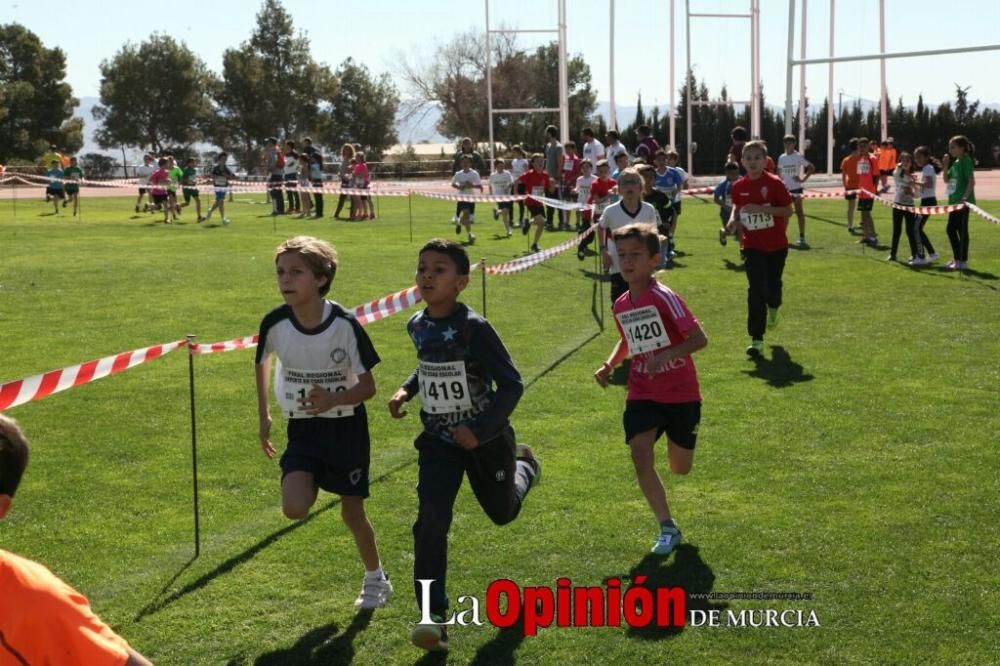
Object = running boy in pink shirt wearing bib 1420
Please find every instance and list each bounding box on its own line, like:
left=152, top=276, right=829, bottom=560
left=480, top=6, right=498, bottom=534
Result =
left=594, top=224, right=708, bottom=555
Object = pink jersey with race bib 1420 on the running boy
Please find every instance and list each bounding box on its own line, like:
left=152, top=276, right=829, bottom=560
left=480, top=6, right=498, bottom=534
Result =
left=613, top=280, right=701, bottom=403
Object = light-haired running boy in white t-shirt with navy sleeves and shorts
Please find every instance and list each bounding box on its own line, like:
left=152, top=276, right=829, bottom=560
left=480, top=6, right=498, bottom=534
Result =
left=255, top=236, right=392, bottom=609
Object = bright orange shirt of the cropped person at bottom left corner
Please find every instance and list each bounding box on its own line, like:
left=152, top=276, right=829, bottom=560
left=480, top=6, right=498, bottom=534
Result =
left=0, top=550, right=128, bottom=666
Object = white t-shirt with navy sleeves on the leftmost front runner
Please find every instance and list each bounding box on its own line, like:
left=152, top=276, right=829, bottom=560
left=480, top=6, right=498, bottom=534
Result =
left=256, top=301, right=380, bottom=419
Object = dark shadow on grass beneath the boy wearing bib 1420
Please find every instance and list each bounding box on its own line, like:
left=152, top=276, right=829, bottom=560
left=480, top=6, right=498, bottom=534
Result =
left=604, top=544, right=729, bottom=641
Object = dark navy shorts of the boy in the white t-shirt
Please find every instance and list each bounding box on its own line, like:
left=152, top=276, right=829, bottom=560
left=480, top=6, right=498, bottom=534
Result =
left=281, top=405, right=371, bottom=497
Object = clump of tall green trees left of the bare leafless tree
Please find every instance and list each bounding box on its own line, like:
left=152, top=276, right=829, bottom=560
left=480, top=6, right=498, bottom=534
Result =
left=94, top=0, right=399, bottom=168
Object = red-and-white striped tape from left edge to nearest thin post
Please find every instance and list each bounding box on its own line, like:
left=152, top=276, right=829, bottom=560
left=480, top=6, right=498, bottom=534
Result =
left=0, top=340, right=187, bottom=412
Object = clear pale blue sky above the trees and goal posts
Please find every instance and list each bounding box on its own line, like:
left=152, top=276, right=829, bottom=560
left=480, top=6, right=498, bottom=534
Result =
left=0, top=0, right=1000, bottom=127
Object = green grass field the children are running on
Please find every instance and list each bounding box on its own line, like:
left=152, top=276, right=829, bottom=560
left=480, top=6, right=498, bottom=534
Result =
left=0, top=188, right=1000, bottom=665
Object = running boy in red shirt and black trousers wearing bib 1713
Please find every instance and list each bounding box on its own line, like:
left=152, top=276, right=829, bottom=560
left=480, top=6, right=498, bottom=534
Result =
left=727, top=141, right=792, bottom=359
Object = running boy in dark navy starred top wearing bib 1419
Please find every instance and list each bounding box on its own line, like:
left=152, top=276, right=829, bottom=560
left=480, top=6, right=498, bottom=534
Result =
left=389, top=239, right=541, bottom=651
